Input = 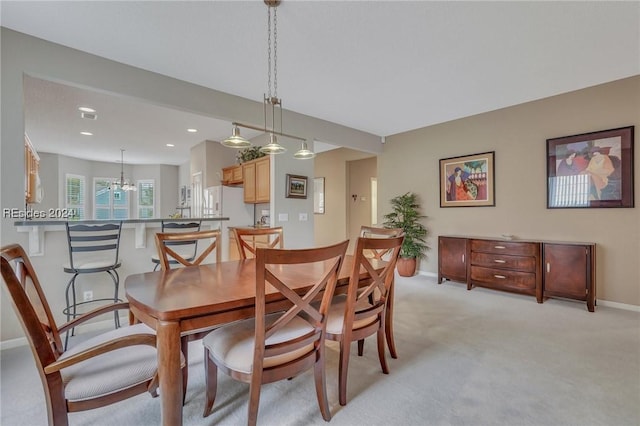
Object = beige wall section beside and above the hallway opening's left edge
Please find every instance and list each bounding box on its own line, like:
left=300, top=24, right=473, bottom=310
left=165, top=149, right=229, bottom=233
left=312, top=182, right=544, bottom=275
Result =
left=314, top=148, right=372, bottom=250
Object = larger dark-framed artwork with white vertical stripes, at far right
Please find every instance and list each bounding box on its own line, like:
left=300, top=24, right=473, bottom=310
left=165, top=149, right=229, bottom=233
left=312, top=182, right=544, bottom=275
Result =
left=547, top=126, right=634, bottom=209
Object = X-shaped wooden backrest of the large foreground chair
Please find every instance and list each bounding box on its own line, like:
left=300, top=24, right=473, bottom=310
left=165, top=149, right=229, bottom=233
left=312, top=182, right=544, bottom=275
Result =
left=253, top=241, right=349, bottom=381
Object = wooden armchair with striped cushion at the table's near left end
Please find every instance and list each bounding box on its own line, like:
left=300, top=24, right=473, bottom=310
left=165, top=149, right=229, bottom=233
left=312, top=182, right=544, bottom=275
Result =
left=0, top=244, right=171, bottom=426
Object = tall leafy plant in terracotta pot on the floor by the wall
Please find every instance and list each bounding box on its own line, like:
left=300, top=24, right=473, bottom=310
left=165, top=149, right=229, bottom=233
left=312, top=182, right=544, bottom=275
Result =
left=384, top=192, right=429, bottom=277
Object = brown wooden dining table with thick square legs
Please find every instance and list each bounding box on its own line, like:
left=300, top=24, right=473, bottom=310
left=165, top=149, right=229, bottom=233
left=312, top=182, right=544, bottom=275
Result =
left=125, top=255, right=393, bottom=426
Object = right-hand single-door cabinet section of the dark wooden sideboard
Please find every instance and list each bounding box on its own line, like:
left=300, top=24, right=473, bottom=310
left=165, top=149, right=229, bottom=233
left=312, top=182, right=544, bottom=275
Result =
left=543, top=243, right=596, bottom=312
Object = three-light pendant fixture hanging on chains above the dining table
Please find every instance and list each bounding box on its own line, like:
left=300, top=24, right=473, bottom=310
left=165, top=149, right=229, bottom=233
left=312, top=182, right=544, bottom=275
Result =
left=221, top=0, right=316, bottom=160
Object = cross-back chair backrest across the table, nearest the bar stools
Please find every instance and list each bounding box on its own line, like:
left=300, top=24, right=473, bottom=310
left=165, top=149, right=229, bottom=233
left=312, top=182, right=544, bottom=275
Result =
left=156, top=229, right=220, bottom=270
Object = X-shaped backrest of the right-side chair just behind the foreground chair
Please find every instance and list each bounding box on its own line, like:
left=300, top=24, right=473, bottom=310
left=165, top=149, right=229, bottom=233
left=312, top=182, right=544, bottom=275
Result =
left=343, top=235, right=404, bottom=332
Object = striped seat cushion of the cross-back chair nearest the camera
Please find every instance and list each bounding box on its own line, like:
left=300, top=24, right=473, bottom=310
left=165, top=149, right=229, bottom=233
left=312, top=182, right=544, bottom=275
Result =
left=202, top=314, right=313, bottom=374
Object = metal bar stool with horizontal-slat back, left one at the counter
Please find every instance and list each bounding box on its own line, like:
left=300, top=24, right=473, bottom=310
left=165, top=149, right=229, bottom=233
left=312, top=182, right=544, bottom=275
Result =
left=62, top=222, right=122, bottom=349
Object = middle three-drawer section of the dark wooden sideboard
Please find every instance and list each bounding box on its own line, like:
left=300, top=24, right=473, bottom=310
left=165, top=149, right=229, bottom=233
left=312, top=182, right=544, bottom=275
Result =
left=468, top=239, right=542, bottom=303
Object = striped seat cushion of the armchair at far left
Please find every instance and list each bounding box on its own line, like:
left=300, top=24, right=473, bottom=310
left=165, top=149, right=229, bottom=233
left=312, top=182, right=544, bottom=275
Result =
left=60, top=324, right=158, bottom=401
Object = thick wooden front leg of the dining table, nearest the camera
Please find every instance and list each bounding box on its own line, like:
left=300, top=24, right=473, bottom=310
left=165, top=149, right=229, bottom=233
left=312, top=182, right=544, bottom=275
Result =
left=156, top=321, right=182, bottom=426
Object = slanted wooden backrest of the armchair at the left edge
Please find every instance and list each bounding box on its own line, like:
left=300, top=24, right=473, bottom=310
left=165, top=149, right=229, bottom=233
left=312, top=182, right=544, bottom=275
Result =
left=0, top=244, right=64, bottom=368
